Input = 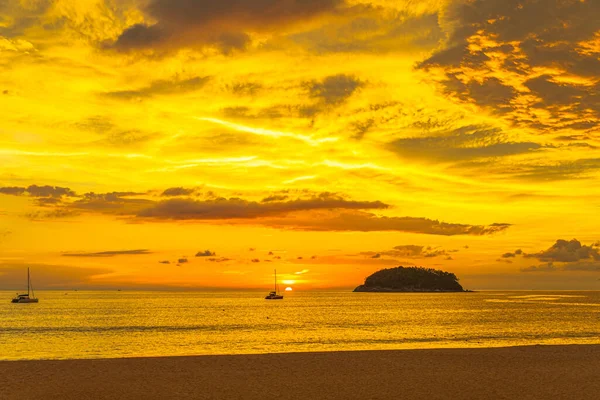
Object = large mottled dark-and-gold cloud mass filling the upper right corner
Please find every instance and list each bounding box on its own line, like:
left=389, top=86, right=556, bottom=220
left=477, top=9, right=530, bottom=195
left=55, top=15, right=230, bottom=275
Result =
left=418, top=0, right=600, bottom=132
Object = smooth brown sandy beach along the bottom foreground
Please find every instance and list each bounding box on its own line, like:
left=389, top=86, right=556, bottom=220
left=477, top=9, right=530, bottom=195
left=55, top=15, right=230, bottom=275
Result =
left=0, top=345, right=600, bottom=400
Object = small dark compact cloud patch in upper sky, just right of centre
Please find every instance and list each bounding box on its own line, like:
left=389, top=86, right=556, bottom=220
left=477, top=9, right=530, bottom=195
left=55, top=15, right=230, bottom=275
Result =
left=306, top=74, right=364, bottom=106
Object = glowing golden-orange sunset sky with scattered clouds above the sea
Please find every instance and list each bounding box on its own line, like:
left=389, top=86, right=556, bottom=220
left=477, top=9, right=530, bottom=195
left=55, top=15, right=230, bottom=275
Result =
left=0, top=0, right=600, bottom=290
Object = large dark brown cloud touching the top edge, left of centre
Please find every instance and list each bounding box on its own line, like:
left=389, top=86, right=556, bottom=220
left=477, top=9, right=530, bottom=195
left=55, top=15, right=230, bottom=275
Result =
left=109, top=0, right=344, bottom=53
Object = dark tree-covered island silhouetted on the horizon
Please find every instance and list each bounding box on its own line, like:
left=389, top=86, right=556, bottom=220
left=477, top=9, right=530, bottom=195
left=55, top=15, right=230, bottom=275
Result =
left=354, top=267, right=468, bottom=292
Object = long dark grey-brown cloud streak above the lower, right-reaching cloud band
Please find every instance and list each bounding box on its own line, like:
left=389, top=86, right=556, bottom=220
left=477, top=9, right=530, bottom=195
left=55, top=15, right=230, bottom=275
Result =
left=137, top=193, right=388, bottom=220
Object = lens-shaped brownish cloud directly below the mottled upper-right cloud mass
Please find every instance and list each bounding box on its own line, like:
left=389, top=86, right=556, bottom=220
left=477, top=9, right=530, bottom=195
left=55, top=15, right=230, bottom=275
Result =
left=389, top=125, right=543, bottom=162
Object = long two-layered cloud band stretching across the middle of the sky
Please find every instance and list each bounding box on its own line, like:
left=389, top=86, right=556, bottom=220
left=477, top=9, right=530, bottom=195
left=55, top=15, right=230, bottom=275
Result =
left=12, top=184, right=510, bottom=236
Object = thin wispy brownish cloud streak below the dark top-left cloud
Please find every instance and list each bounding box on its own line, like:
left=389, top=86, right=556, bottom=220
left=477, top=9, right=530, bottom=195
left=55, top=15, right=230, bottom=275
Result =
left=105, top=76, right=210, bottom=100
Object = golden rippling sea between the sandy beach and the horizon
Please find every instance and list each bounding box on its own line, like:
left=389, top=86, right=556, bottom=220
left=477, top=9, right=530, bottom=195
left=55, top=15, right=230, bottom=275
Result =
left=0, top=291, right=600, bottom=360
